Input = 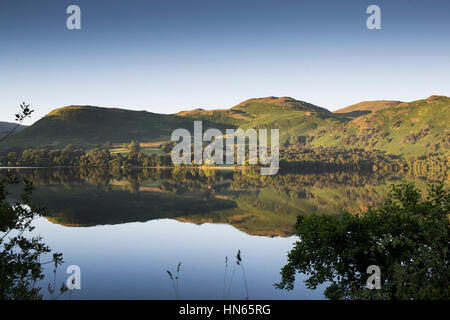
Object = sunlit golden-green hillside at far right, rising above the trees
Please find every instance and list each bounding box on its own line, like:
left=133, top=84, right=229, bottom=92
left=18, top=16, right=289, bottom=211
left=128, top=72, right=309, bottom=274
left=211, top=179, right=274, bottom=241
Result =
left=313, top=96, right=450, bottom=155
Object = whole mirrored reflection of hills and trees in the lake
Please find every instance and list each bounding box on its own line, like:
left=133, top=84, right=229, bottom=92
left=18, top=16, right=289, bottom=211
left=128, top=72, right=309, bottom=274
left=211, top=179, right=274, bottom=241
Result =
left=4, top=169, right=432, bottom=236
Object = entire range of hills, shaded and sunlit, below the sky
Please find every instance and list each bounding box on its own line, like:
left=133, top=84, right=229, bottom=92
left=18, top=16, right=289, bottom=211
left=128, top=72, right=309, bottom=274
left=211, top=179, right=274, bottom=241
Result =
left=0, top=96, right=450, bottom=155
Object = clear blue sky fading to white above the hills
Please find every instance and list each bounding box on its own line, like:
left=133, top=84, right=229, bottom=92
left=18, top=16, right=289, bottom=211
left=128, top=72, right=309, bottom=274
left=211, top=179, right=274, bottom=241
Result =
left=0, top=0, right=450, bottom=123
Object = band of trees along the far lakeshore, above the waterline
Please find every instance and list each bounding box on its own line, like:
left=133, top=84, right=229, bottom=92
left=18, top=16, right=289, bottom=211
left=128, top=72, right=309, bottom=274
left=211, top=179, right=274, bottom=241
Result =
left=0, top=141, right=450, bottom=179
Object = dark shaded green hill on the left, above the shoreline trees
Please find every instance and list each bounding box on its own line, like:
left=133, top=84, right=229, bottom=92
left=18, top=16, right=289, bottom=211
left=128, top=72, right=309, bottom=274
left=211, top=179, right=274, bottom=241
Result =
left=1, top=106, right=232, bottom=149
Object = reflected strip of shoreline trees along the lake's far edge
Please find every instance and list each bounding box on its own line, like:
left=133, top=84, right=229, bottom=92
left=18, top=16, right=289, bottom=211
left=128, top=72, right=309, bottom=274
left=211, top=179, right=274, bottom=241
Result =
left=0, top=167, right=408, bottom=193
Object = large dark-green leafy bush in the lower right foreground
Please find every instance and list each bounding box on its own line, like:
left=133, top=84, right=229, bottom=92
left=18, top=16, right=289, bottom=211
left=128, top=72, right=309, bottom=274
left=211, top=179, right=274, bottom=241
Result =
left=275, top=183, right=450, bottom=299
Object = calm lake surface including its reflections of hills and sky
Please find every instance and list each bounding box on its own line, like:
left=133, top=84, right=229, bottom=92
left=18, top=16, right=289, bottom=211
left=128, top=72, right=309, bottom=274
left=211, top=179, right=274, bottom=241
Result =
left=2, top=169, right=425, bottom=299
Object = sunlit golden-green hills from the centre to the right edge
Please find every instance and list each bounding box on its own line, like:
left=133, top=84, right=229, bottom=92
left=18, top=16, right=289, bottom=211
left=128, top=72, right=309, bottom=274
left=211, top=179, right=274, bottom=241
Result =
left=178, top=96, right=450, bottom=156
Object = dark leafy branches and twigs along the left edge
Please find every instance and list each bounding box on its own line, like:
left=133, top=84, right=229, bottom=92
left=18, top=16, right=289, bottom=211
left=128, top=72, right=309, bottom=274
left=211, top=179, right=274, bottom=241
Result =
left=0, top=103, right=67, bottom=300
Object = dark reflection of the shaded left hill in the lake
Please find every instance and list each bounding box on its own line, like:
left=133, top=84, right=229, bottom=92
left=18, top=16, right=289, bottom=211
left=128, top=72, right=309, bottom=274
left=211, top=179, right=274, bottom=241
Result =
left=29, top=185, right=235, bottom=226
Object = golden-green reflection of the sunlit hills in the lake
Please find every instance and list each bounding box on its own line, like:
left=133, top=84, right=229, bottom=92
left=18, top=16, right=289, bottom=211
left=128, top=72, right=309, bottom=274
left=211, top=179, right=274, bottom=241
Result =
left=178, top=181, right=416, bottom=236
